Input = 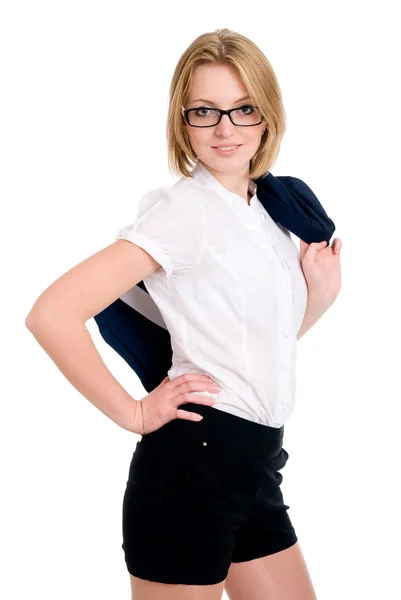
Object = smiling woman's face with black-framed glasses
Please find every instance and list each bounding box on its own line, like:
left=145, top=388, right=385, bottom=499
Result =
left=184, top=64, right=265, bottom=177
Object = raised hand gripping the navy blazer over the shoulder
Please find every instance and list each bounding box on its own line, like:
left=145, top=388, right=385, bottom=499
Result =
left=300, top=238, right=342, bottom=298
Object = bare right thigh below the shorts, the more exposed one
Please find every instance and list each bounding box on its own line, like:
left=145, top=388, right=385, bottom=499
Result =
left=225, top=542, right=316, bottom=600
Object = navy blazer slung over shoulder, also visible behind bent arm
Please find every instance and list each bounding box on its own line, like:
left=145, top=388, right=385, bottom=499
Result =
left=94, top=172, right=335, bottom=393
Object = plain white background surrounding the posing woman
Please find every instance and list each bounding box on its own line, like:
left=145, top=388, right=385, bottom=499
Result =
left=0, top=0, right=401, bottom=600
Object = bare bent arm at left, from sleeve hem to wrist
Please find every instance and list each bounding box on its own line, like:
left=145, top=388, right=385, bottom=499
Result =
left=25, top=240, right=160, bottom=433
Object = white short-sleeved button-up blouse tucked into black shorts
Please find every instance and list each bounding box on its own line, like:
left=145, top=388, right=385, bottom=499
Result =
left=115, top=163, right=307, bottom=427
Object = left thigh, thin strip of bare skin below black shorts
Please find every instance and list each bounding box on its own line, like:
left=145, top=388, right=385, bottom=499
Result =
left=130, top=574, right=224, bottom=600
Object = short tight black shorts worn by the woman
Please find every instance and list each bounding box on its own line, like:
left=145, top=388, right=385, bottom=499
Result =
left=122, top=403, right=298, bottom=585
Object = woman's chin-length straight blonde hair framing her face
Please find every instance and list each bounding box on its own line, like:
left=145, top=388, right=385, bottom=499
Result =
left=166, top=29, right=286, bottom=179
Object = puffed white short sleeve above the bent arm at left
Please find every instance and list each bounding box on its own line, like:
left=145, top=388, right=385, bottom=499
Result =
left=115, top=185, right=205, bottom=277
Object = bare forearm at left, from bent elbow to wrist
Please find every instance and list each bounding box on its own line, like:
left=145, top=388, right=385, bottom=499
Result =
left=26, top=314, right=141, bottom=433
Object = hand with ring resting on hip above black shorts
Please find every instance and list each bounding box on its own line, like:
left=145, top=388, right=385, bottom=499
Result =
left=135, top=373, right=220, bottom=434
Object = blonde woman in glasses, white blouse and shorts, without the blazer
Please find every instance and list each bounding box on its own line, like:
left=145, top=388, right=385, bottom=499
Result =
left=27, top=29, right=341, bottom=600
